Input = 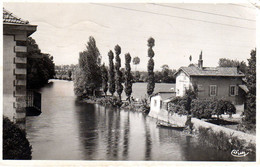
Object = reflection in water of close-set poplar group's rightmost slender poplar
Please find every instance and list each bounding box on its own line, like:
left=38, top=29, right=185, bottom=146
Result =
left=123, top=111, right=130, bottom=159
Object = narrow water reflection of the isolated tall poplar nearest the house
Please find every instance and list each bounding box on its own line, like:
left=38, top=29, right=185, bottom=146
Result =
left=143, top=117, right=152, bottom=160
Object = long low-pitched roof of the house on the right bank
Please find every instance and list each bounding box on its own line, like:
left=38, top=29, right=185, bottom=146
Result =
left=174, top=66, right=245, bottom=77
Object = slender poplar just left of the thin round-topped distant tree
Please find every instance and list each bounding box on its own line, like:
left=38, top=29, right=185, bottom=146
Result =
left=125, top=53, right=133, bottom=102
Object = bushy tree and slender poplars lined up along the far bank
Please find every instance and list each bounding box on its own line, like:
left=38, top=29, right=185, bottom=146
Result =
left=74, top=37, right=155, bottom=101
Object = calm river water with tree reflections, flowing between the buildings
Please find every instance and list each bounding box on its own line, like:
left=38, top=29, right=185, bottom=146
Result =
left=26, top=80, right=253, bottom=161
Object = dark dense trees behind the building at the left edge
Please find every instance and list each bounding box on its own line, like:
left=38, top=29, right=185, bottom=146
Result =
left=27, top=37, right=55, bottom=89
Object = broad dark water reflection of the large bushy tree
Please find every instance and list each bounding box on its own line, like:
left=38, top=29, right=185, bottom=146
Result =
left=75, top=103, right=98, bottom=160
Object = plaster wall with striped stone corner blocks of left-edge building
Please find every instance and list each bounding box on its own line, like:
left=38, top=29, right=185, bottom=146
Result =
left=3, top=32, right=27, bottom=128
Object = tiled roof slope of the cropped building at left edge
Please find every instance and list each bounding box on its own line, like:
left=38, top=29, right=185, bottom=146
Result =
left=3, top=8, right=29, bottom=24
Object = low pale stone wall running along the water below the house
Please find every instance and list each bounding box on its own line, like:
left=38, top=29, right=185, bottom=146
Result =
left=149, top=109, right=256, bottom=144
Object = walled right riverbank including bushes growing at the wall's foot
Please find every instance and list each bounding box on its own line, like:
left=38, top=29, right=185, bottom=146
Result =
left=149, top=109, right=256, bottom=157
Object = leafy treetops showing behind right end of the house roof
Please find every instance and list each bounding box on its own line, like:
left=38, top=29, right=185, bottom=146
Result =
left=218, top=58, right=247, bottom=73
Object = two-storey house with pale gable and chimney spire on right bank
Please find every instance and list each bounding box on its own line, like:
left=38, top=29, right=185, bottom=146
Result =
left=175, top=53, right=246, bottom=104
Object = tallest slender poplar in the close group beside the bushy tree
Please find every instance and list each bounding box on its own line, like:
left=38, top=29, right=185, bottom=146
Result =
left=115, top=45, right=123, bottom=101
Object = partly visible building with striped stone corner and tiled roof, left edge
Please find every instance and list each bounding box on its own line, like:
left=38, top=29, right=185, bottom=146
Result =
left=3, top=9, right=37, bottom=129
